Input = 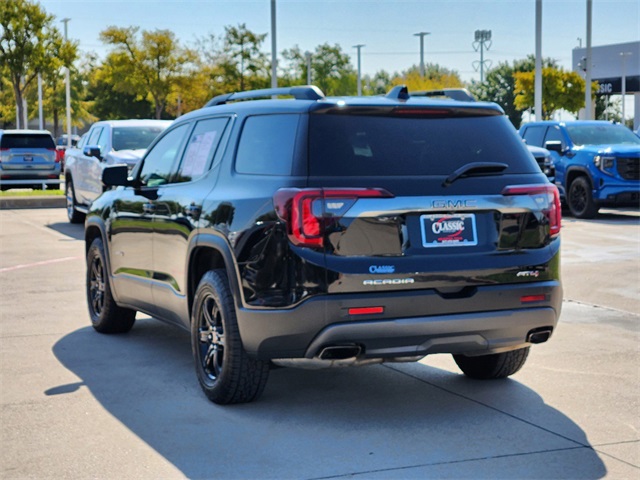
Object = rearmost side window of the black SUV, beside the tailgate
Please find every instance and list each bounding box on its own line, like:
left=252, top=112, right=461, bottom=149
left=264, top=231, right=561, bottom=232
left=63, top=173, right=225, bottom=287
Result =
left=236, top=114, right=300, bottom=175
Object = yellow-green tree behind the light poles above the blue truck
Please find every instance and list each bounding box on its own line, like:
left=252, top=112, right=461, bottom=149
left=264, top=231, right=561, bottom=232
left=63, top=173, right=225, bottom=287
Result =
left=514, top=67, right=597, bottom=120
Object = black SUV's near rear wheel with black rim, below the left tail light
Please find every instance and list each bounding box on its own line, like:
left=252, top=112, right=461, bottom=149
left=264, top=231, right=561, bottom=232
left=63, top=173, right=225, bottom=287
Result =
left=191, top=270, right=269, bottom=405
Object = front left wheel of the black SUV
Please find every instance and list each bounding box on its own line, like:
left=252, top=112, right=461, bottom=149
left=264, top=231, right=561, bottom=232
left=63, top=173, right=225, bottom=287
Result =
left=86, top=238, right=136, bottom=333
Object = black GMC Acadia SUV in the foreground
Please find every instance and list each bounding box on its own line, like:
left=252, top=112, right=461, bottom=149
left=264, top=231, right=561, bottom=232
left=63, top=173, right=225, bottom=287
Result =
left=85, top=86, right=562, bottom=404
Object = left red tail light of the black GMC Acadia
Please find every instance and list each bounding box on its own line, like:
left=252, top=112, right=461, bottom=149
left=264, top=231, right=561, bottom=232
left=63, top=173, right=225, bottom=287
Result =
left=273, top=188, right=393, bottom=248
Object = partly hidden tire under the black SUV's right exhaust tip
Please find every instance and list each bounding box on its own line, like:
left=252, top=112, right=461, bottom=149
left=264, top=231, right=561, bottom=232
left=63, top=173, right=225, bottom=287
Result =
left=453, top=347, right=529, bottom=380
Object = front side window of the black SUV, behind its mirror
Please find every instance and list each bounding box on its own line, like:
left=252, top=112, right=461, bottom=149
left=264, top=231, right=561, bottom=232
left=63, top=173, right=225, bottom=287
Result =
left=140, top=124, right=189, bottom=187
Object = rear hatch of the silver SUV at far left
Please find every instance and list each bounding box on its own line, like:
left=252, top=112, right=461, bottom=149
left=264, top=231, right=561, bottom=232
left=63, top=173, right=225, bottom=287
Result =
left=0, top=133, right=57, bottom=174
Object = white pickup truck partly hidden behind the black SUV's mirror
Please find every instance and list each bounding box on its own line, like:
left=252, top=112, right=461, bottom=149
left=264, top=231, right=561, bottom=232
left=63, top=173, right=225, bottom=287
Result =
left=64, top=120, right=171, bottom=223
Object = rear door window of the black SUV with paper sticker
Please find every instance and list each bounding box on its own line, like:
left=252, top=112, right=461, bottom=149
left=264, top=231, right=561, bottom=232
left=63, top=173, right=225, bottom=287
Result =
left=174, top=118, right=228, bottom=182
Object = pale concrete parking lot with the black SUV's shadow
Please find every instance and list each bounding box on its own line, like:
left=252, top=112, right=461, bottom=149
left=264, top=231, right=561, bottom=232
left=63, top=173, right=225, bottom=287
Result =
left=0, top=208, right=640, bottom=479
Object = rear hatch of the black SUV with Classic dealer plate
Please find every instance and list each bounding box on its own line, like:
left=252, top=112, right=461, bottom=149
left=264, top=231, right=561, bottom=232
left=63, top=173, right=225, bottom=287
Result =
left=284, top=106, right=560, bottom=295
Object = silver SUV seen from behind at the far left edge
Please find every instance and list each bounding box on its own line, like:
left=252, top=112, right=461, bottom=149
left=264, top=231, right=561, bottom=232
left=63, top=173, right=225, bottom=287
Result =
left=0, top=130, right=60, bottom=190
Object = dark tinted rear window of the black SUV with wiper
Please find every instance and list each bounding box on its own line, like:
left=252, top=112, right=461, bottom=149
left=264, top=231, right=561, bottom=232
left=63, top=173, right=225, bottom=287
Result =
left=309, top=114, right=539, bottom=176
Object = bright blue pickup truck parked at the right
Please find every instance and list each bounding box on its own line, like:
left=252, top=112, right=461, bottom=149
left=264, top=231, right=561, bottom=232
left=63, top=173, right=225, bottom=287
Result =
left=520, top=120, right=640, bottom=218
